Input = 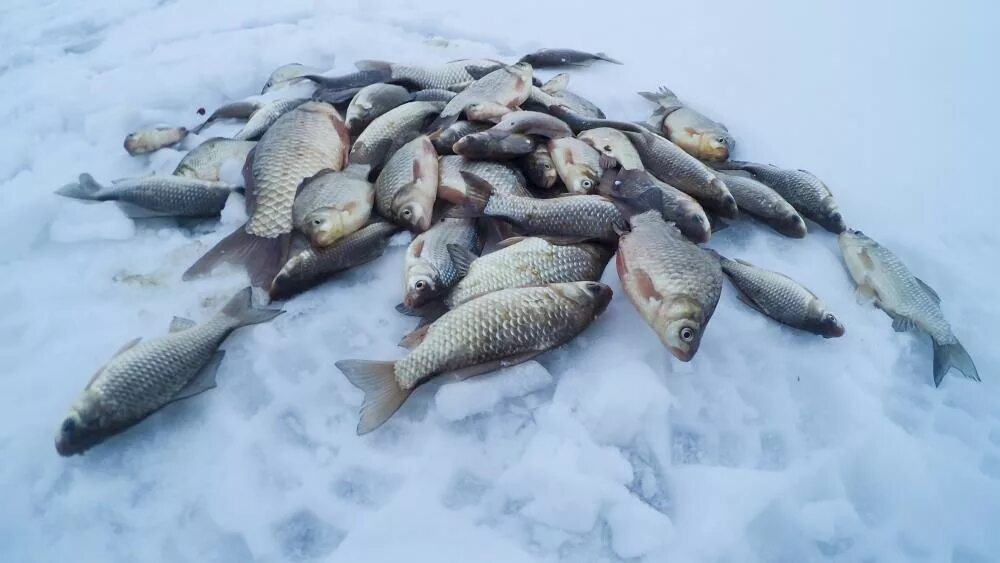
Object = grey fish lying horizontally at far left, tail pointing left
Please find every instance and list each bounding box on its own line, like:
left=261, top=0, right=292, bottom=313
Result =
left=56, top=174, right=233, bottom=219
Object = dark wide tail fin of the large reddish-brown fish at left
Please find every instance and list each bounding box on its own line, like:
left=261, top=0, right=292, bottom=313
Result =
left=182, top=225, right=291, bottom=288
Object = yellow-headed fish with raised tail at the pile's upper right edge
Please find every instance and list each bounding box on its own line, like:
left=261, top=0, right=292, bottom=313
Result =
left=639, top=86, right=736, bottom=160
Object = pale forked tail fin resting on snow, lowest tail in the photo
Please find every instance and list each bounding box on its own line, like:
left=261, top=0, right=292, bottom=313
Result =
left=335, top=360, right=410, bottom=436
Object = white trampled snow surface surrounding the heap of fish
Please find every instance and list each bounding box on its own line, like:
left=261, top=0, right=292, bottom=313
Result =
left=0, top=0, right=1000, bottom=563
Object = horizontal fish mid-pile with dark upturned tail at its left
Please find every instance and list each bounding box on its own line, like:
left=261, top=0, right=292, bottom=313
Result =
left=450, top=172, right=625, bottom=242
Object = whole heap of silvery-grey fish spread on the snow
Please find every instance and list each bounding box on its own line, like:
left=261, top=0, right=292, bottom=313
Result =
left=50, top=49, right=979, bottom=455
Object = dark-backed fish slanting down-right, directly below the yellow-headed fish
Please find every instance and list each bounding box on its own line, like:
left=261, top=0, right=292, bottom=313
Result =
left=625, top=131, right=739, bottom=219
